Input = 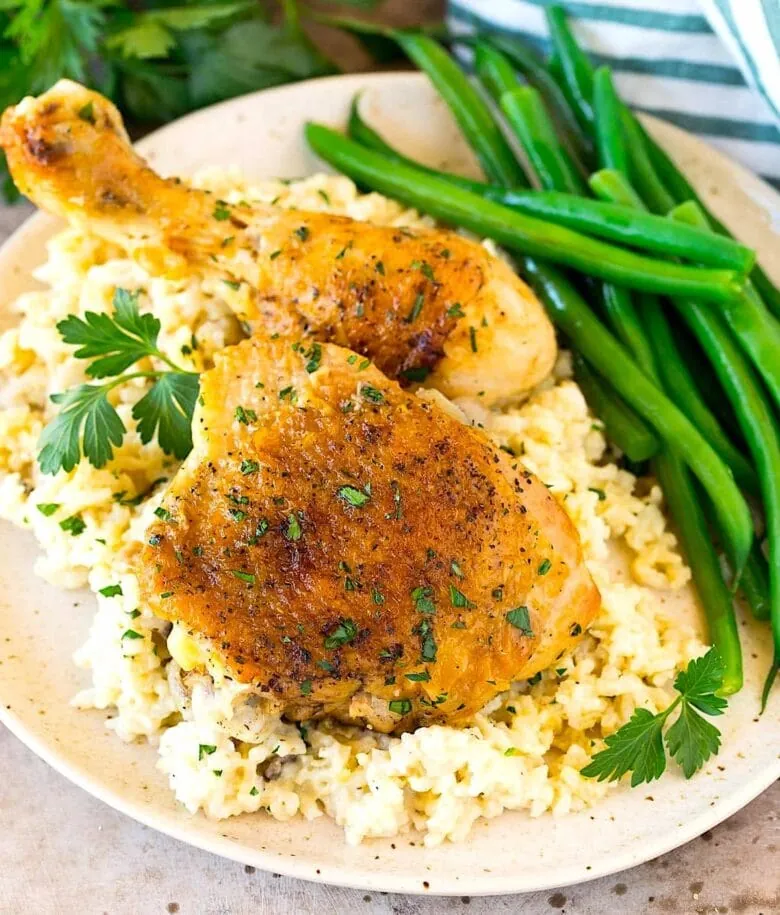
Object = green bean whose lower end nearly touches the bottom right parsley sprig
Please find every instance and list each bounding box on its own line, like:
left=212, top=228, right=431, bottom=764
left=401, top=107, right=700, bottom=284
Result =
left=655, top=453, right=742, bottom=696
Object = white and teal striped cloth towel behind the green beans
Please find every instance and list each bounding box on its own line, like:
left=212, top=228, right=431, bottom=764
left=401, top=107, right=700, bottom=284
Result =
left=448, top=0, right=780, bottom=188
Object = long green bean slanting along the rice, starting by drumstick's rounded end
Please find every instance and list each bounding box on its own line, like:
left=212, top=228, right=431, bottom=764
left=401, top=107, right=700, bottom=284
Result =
left=526, top=259, right=756, bottom=573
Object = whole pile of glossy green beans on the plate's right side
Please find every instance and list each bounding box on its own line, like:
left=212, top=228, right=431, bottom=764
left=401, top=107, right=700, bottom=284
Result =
left=306, top=7, right=780, bottom=704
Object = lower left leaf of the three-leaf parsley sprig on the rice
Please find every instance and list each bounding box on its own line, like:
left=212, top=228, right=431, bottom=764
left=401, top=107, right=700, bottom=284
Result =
left=38, top=384, right=126, bottom=474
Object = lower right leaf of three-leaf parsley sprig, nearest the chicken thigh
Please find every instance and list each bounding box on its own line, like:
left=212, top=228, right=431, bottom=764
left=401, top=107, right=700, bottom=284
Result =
left=133, top=372, right=199, bottom=460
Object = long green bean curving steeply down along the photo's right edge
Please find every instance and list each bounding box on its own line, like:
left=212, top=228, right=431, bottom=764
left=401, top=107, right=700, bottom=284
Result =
left=678, top=302, right=780, bottom=702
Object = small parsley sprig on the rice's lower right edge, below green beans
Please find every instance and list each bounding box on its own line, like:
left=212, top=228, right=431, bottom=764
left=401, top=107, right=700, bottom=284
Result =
left=581, top=648, right=726, bottom=788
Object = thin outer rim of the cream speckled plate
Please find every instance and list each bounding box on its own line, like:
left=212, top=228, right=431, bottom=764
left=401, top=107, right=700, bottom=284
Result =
left=0, top=71, right=780, bottom=896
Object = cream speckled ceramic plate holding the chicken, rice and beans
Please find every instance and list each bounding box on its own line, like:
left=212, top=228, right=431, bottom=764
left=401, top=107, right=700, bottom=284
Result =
left=0, top=73, right=780, bottom=895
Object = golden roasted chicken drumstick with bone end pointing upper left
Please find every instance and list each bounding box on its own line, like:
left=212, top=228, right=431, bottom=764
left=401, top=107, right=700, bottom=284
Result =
left=0, top=80, right=556, bottom=405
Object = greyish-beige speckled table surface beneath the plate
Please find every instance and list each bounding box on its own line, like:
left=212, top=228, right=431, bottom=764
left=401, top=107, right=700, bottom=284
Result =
left=0, top=200, right=780, bottom=915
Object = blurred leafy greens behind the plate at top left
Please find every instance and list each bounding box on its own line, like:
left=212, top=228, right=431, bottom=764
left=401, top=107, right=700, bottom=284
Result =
left=0, top=0, right=444, bottom=199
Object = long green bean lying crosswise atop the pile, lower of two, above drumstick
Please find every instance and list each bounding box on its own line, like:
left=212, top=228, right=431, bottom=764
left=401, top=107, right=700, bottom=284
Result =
left=306, top=123, right=742, bottom=302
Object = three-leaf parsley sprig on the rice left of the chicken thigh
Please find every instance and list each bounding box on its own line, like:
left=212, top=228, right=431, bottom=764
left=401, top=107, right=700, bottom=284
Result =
left=38, top=288, right=198, bottom=474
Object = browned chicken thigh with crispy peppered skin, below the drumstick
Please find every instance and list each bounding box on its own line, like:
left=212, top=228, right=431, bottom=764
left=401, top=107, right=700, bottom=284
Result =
left=139, top=337, right=599, bottom=731
